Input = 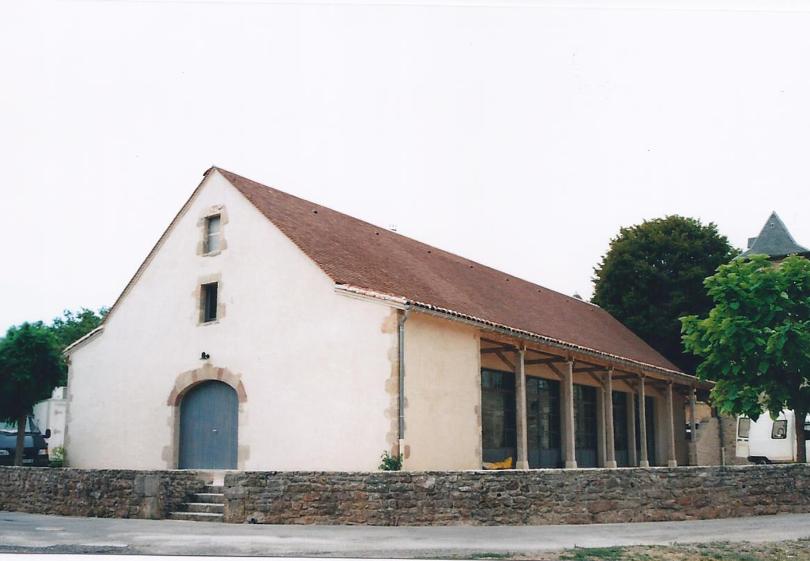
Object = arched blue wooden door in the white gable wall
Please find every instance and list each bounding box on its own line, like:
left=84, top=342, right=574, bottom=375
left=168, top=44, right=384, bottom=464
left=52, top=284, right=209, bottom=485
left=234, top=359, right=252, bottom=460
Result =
left=179, top=381, right=239, bottom=469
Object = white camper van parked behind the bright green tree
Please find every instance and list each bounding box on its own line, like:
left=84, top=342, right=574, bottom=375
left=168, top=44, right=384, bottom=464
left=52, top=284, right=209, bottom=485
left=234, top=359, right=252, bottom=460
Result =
left=737, top=411, right=810, bottom=464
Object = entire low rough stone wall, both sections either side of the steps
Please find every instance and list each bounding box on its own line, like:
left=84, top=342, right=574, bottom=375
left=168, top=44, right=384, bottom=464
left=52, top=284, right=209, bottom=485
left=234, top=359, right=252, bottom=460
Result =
left=0, top=464, right=810, bottom=526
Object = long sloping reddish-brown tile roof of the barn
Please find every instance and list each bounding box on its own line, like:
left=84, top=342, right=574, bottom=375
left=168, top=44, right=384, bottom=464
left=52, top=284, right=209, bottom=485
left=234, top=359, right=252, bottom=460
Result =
left=212, top=168, right=679, bottom=371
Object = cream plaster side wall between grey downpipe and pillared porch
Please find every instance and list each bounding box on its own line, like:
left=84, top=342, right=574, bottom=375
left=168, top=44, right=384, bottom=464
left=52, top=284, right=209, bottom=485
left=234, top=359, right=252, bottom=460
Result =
left=403, top=313, right=481, bottom=470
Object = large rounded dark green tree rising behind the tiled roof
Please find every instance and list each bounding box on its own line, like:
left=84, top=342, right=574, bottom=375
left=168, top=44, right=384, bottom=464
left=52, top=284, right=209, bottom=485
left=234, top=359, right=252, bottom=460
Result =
left=592, top=216, right=738, bottom=372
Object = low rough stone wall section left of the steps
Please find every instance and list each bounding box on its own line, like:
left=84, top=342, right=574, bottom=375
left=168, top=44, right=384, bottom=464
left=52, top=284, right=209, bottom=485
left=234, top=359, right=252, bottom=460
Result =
left=0, top=467, right=205, bottom=518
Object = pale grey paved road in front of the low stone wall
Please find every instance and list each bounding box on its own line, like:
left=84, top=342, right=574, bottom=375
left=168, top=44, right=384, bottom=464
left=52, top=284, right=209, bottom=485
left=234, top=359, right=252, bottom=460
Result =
left=0, top=512, right=810, bottom=558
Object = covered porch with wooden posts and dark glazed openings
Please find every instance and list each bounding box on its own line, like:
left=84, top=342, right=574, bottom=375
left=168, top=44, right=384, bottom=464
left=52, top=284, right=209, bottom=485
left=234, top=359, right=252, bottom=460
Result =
left=480, top=332, right=707, bottom=470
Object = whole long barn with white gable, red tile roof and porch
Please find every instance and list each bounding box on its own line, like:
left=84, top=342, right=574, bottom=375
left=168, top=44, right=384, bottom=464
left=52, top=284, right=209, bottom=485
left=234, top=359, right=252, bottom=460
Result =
left=66, top=168, right=702, bottom=471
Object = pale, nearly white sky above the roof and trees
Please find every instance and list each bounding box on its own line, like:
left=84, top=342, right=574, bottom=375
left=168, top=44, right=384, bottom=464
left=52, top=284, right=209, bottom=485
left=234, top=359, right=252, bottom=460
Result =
left=0, top=0, right=810, bottom=331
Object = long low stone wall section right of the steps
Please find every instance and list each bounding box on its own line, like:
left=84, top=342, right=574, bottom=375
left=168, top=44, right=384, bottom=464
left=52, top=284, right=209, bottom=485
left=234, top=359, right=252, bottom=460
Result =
left=225, top=465, right=810, bottom=526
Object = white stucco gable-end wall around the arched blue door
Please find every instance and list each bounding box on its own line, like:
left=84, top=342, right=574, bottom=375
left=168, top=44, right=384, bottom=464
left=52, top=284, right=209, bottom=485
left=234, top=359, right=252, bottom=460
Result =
left=66, top=171, right=397, bottom=470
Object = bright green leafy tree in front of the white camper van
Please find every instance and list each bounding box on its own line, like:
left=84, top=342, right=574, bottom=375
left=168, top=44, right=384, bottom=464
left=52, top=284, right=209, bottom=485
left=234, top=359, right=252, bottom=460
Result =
left=682, top=255, right=810, bottom=462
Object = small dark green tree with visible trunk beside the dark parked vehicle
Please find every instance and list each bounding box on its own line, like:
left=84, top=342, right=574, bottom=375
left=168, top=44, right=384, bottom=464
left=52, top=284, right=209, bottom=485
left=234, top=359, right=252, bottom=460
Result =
left=0, top=322, right=64, bottom=466
